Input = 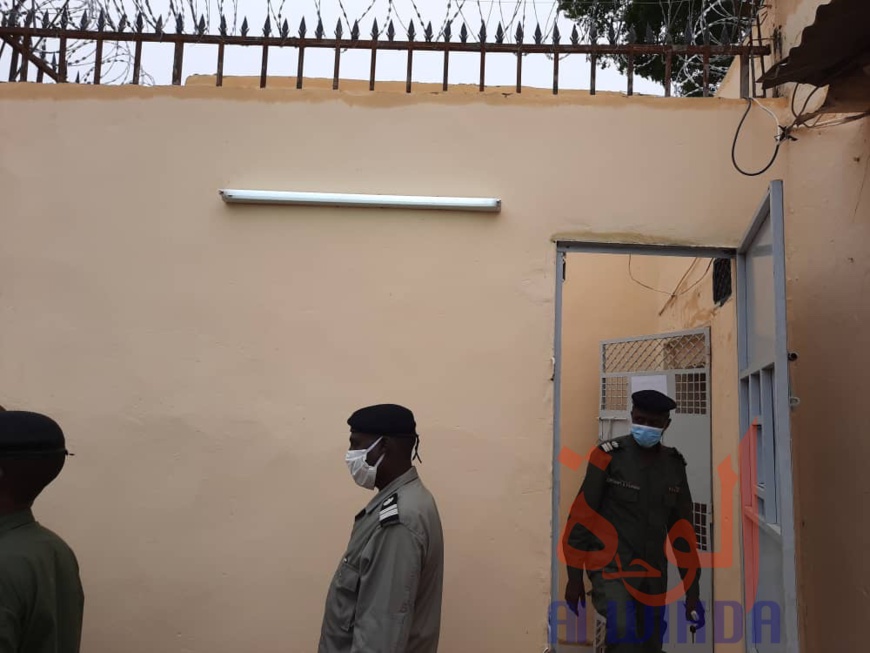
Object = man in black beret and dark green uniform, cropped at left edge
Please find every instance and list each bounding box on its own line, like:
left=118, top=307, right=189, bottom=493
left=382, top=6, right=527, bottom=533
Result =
left=0, top=410, right=84, bottom=653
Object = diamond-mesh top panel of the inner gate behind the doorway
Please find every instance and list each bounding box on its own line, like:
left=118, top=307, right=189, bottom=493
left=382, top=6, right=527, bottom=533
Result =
left=601, top=333, right=707, bottom=374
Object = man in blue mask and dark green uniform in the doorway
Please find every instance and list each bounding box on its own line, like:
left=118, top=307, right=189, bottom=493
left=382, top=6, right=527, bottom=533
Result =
left=565, top=390, right=704, bottom=653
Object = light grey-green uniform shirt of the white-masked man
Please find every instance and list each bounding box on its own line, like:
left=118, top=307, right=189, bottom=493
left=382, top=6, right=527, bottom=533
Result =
left=318, top=467, right=444, bottom=653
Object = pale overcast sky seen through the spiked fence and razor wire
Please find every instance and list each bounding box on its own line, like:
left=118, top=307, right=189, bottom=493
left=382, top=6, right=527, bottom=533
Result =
left=0, top=0, right=663, bottom=95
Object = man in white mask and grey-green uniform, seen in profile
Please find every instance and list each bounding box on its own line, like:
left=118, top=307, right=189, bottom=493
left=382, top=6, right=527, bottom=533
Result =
left=318, top=404, right=444, bottom=653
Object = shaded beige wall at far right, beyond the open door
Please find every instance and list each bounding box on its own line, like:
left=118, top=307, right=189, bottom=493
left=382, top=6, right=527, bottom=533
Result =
left=784, top=120, right=870, bottom=653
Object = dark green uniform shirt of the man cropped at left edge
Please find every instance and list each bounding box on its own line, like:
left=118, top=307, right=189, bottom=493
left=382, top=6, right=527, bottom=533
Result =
left=0, top=510, right=84, bottom=653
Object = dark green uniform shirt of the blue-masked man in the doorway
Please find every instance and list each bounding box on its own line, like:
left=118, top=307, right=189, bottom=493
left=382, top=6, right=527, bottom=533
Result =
left=568, top=435, right=701, bottom=598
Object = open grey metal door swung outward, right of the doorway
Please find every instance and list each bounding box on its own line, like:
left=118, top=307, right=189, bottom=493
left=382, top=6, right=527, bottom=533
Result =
left=737, top=181, right=799, bottom=653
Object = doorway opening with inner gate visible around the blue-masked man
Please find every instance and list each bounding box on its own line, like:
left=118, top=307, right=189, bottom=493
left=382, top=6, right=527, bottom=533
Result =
left=550, top=242, right=742, bottom=653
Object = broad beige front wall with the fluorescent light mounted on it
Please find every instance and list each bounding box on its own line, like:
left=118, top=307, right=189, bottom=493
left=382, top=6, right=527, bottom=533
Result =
left=0, top=85, right=776, bottom=653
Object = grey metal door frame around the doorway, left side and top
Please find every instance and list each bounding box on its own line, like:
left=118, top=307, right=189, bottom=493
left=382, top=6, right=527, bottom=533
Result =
left=547, top=240, right=740, bottom=651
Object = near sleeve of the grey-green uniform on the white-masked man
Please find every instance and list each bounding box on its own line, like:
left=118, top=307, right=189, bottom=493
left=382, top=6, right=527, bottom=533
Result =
left=351, top=523, right=423, bottom=653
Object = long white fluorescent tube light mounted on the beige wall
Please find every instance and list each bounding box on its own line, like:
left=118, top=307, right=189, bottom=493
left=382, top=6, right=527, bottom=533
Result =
left=220, top=189, right=501, bottom=213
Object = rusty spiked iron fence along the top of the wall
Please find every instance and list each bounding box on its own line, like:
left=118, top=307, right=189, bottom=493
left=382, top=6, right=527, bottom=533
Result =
left=0, top=7, right=770, bottom=96
